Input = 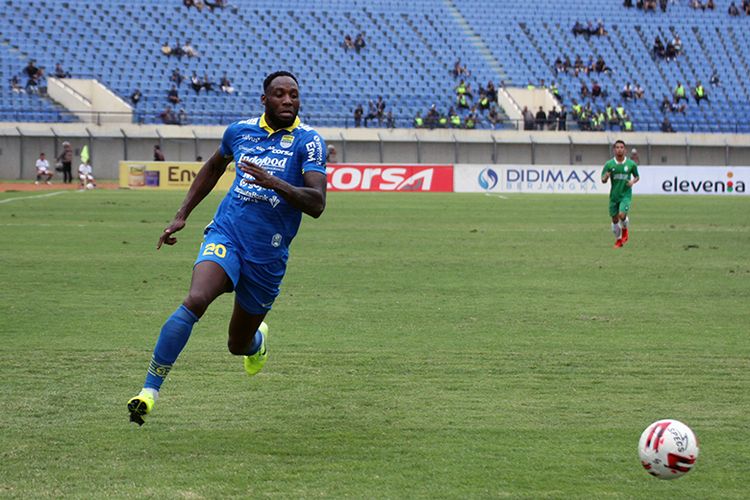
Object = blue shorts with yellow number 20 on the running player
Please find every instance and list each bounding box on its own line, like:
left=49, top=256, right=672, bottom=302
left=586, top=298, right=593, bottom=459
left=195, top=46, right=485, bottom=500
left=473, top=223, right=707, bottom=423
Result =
left=193, top=227, right=286, bottom=314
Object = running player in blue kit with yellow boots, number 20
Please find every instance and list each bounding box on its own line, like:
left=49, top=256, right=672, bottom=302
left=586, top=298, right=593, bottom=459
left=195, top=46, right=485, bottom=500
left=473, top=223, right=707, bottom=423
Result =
left=128, top=71, right=326, bottom=425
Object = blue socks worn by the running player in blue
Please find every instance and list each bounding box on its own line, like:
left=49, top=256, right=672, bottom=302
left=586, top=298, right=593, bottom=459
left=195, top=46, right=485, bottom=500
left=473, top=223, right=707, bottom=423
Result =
left=143, top=305, right=200, bottom=391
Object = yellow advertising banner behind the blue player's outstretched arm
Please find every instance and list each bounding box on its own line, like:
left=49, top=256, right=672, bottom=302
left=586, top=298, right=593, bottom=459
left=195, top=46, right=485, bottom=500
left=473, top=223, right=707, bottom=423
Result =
left=120, top=161, right=235, bottom=191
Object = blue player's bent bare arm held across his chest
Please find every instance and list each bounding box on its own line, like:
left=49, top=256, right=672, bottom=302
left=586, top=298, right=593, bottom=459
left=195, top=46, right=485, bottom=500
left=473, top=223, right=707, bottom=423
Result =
left=239, top=160, right=326, bottom=219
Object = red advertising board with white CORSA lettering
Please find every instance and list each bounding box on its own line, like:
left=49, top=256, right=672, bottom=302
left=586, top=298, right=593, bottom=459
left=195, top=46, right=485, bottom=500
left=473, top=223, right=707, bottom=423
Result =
left=326, top=163, right=453, bottom=193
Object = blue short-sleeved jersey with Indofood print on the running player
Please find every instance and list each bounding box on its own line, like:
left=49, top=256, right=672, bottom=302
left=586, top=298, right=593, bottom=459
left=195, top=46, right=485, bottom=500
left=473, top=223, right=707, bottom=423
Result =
left=211, top=115, right=326, bottom=264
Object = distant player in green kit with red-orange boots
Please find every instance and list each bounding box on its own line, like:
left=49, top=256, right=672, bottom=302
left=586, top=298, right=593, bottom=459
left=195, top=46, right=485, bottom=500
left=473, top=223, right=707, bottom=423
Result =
left=602, top=141, right=640, bottom=248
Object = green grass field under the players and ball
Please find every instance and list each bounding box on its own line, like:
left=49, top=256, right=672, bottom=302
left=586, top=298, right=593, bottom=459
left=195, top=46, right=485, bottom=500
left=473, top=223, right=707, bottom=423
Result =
left=0, top=191, right=750, bottom=499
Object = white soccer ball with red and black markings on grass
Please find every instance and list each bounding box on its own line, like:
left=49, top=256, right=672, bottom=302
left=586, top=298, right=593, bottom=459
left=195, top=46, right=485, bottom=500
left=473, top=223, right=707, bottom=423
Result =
left=638, top=419, right=698, bottom=479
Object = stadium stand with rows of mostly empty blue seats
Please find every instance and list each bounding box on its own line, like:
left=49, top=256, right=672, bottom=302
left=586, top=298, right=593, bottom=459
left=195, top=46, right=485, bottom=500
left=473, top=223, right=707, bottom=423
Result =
left=0, top=0, right=750, bottom=132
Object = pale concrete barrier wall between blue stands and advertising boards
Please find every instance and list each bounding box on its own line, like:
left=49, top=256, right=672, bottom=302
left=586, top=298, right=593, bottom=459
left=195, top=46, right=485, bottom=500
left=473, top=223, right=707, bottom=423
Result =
left=0, top=123, right=750, bottom=179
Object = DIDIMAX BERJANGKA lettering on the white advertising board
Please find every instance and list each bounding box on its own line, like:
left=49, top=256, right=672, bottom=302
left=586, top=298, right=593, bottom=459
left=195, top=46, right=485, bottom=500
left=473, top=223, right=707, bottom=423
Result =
left=503, top=167, right=599, bottom=193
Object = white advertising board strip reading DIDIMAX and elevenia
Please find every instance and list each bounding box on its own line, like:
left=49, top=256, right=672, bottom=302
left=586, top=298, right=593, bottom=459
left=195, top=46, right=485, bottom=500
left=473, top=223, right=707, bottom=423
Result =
left=454, top=164, right=750, bottom=196
